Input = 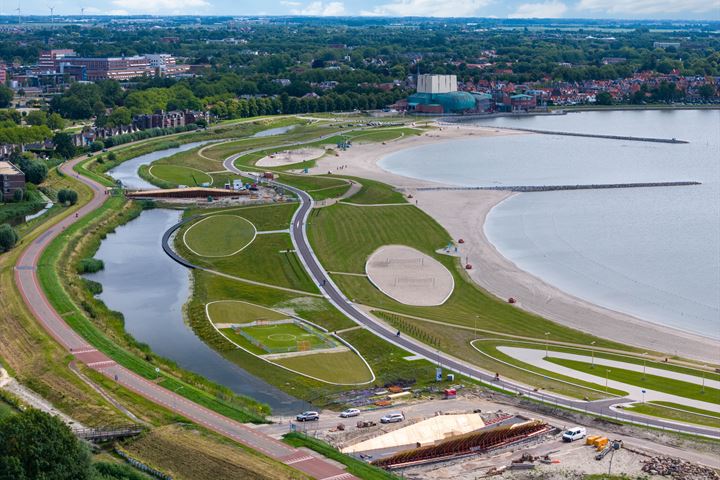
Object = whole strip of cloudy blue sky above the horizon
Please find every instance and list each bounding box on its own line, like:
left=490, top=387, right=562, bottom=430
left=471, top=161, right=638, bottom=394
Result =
left=0, top=0, right=720, bottom=20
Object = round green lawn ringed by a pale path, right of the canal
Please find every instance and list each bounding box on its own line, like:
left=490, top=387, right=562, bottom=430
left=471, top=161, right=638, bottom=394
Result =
left=183, top=213, right=255, bottom=257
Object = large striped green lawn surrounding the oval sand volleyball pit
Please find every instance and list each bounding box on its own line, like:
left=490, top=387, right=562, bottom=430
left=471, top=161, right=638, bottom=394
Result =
left=308, top=204, right=625, bottom=349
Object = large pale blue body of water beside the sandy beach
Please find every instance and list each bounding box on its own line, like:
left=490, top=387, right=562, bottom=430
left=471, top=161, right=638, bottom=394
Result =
left=380, top=110, right=720, bottom=338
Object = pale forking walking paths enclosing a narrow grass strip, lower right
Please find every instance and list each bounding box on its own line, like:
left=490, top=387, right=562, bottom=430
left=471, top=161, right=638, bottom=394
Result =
left=497, top=346, right=720, bottom=413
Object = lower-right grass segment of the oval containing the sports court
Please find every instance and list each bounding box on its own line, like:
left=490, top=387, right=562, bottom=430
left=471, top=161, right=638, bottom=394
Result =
left=273, top=350, right=372, bottom=383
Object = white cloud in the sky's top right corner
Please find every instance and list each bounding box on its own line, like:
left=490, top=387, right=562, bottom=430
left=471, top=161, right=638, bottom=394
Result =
left=577, top=0, right=718, bottom=16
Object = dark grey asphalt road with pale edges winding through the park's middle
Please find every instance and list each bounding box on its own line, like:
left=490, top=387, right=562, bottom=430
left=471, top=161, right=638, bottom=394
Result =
left=223, top=155, right=720, bottom=438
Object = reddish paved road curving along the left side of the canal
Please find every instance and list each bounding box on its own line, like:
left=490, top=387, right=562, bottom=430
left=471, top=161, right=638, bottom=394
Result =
left=15, top=157, right=356, bottom=480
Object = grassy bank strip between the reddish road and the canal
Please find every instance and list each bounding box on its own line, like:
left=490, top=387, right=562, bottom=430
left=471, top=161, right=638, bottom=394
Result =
left=38, top=191, right=268, bottom=422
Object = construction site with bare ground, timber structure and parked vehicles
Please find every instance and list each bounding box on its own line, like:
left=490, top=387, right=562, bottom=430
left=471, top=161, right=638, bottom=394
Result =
left=268, top=389, right=720, bottom=480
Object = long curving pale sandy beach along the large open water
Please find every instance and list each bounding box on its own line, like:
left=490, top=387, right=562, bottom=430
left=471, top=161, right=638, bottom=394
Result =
left=310, top=125, right=720, bottom=363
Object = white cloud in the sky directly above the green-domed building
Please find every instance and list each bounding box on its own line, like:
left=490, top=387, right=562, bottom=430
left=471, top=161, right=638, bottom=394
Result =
left=360, top=0, right=492, bottom=17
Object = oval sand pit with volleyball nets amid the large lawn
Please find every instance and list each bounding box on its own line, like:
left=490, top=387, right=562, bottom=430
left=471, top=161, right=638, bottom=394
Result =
left=365, top=245, right=455, bottom=307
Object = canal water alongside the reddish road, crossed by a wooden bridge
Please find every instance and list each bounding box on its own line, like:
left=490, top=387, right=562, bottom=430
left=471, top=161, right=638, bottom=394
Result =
left=87, top=142, right=309, bottom=415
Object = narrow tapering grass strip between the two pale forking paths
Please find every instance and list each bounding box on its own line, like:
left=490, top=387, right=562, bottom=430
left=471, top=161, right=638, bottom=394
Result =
left=547, top=355, right=720, bottom=404
